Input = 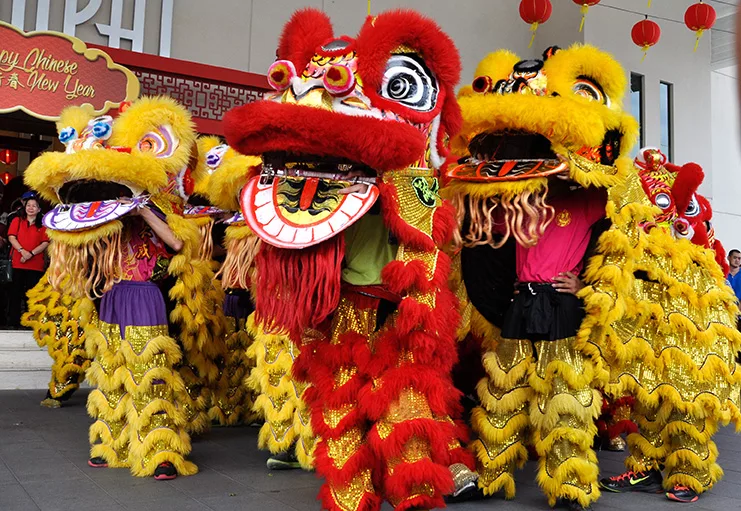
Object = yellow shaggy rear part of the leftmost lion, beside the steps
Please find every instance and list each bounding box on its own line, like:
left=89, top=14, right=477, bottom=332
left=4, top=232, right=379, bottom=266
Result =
left=21, top=276, right=94, bottom=406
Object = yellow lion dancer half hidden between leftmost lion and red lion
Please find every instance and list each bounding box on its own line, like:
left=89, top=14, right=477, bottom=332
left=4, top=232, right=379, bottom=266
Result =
left=200, top=137, right=315, bottom=470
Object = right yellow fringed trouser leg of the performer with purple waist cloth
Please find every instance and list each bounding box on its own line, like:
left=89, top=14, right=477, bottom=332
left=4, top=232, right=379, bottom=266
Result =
left=90, top=322, right=198, bottom=477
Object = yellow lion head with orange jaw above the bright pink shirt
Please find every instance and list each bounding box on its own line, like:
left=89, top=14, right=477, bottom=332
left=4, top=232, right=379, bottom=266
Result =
left=446, top=44, right=638, bottom=246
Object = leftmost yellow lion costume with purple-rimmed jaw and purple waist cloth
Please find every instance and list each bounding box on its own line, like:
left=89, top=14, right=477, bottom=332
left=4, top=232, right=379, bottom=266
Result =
left=25, top=98, right=221, bottom=478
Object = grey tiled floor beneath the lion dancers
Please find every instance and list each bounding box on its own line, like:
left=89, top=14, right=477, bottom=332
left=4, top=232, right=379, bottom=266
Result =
left=0, top=390, right=741, bottom=511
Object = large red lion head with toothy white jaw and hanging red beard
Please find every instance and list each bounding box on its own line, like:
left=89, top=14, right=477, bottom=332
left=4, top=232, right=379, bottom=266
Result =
left=225, top=9, right=461, bottom=332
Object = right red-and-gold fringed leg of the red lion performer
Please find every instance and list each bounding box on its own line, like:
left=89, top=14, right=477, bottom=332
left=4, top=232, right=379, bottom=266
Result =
left=360, top=302, right=475, bottom=511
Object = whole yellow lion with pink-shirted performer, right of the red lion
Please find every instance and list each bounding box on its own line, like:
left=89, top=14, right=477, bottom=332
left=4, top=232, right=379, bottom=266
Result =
left=445, top=45, right=739, bottom=509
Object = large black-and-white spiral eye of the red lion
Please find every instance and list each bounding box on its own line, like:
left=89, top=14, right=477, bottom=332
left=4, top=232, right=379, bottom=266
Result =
left=381, top=54, right=438, bottom=112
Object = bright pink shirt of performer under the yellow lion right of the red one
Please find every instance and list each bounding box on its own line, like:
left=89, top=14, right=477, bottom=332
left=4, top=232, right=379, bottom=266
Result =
left=516, top=188, right=606, bottom=283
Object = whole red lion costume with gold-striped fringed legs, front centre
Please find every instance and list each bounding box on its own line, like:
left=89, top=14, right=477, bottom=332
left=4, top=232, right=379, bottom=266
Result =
left=225, top=10, right=470, bottom=511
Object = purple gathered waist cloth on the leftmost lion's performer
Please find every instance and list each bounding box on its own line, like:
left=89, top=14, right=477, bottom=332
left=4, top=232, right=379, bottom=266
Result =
left=99, top=280, right=167, bottom=339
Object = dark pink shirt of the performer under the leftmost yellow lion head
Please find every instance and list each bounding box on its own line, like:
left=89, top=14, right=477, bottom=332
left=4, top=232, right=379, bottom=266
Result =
left=123, top=218, right=170, bottom=282
